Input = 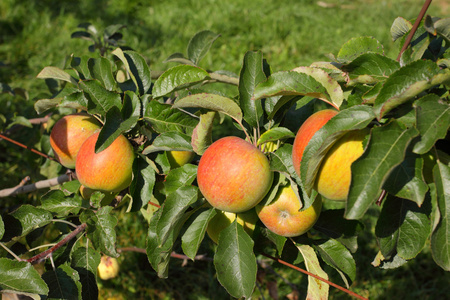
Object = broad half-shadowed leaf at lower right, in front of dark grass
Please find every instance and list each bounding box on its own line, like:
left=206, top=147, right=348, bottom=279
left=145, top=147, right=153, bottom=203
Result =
left=375, top=195, right=431, bottom=260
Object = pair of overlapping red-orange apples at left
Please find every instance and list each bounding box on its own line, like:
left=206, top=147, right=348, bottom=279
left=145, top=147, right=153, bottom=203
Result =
left=50, top=114, right=134, bottom=202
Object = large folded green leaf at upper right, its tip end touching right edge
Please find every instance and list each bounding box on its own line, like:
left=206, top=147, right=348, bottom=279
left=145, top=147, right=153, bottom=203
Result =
left=374, top=60, right=450, bottom=120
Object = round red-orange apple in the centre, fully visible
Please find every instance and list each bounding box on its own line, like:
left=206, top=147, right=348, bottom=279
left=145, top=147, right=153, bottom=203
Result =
left=197, top=136, right=273, bottom=213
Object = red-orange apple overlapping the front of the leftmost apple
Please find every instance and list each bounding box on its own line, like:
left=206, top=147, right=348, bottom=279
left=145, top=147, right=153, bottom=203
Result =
left=75, top=132, right=134, bottom=192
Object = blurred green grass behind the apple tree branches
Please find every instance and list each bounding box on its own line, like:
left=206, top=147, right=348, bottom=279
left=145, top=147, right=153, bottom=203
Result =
left=0, top=0, right=450, bottom=299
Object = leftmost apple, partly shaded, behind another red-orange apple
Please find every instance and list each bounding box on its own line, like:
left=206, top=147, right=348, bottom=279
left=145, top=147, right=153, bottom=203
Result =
left=50, top=114, right=100, bottom=169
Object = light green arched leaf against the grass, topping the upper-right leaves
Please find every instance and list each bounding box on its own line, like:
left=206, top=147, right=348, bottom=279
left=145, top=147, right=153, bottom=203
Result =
left=337, top=36, right=384, bottom=63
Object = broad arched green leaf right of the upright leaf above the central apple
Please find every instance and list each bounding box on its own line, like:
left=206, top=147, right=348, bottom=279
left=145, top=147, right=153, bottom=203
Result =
left=253, top=71, right=331, bottom=103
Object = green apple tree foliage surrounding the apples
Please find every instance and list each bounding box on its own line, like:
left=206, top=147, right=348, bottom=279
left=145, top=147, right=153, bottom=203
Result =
left=0, top=6, right=450, bottom=299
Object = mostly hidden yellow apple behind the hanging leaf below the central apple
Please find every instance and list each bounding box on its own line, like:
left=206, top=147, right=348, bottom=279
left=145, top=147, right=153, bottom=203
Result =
left=206, top=209, right=258, bottom=244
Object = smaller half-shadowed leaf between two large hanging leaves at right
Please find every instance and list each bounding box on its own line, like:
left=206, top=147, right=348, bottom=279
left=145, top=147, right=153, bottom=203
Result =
left=383, top=151, right=428, bottom=206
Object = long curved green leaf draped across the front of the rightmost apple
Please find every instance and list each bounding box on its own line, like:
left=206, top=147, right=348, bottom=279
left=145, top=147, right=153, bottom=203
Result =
left=300, top=105, right=375, bottom=194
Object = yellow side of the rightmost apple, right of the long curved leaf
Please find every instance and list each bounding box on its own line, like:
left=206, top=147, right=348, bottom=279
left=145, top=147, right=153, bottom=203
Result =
left=315, top=128, right=369, bottom=201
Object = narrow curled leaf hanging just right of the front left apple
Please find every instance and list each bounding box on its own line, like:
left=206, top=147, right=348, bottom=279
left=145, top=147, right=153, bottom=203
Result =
left=130, top=155, right=156, bottom=211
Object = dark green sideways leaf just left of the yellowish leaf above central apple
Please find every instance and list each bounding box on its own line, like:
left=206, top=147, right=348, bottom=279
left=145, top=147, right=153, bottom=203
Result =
left=144, top=100, right=198, bottom=133
